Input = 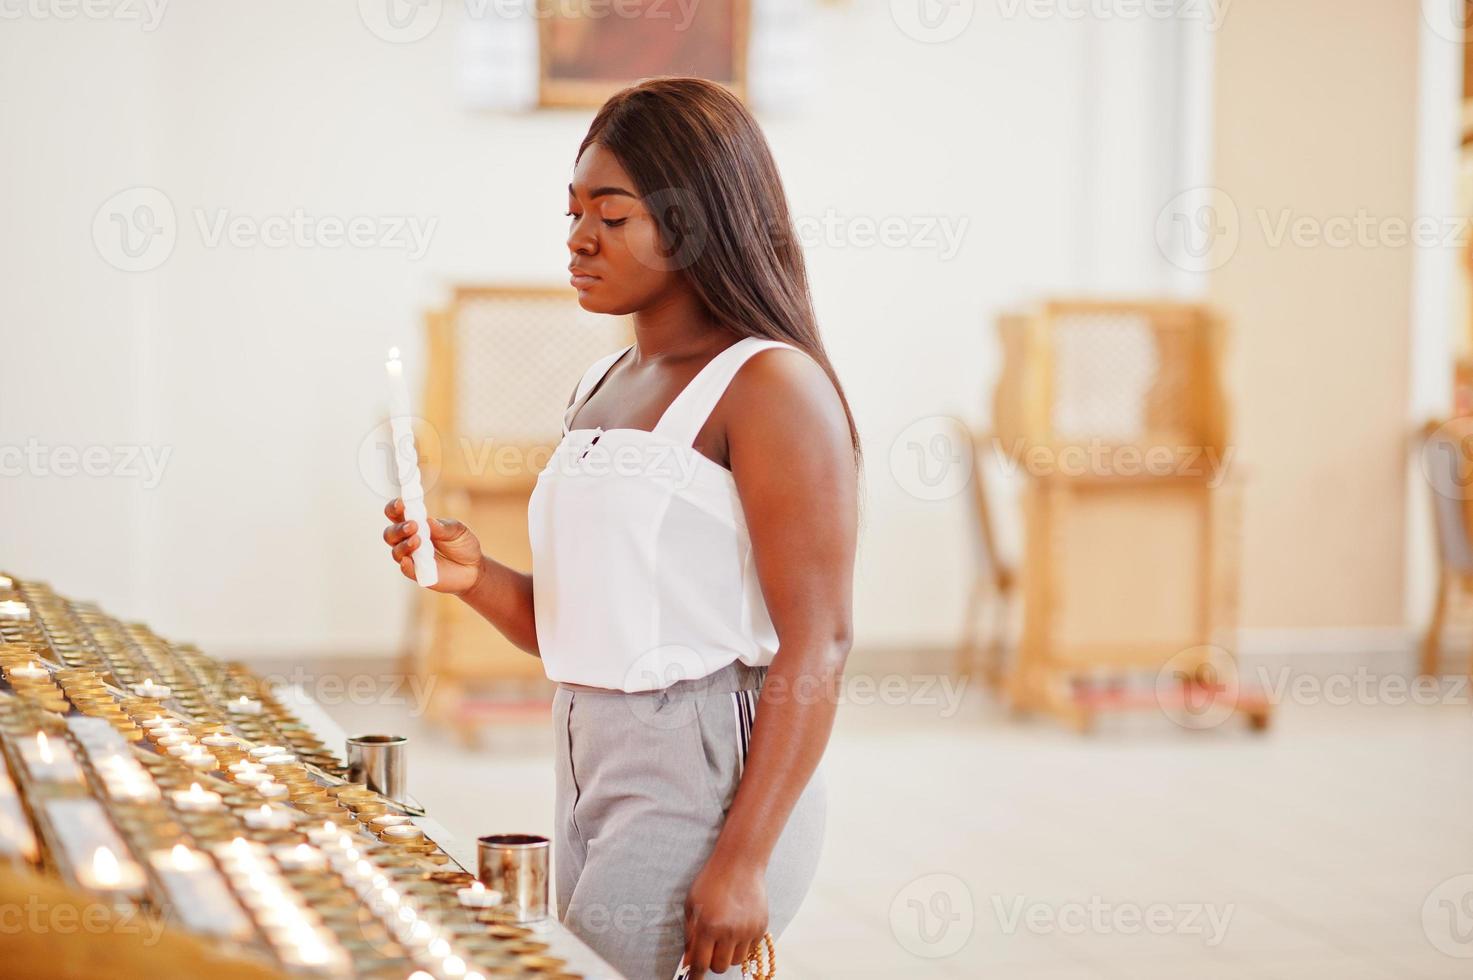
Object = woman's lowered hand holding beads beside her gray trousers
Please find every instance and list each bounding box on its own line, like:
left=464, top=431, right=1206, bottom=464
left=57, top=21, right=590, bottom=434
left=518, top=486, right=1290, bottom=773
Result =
left=685, top=855, right=767, bottom=980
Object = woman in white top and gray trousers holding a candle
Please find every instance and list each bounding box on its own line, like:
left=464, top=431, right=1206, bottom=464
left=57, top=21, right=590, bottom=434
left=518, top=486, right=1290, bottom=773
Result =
left=384, top=78, right=859, bottom=980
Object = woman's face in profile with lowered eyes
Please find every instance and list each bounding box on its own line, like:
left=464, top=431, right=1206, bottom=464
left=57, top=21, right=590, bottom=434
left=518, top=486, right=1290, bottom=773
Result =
left=567, top=143, right=683, bottom=315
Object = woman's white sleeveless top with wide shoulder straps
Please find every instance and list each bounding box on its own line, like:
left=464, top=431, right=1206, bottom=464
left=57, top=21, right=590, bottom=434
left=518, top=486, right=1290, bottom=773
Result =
left=527, top=337, right=798, bottom=691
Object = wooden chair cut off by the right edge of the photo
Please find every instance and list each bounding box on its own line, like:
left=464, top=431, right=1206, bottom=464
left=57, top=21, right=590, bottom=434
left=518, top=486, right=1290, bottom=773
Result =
left=1421, top=419, right=1473, bottom=676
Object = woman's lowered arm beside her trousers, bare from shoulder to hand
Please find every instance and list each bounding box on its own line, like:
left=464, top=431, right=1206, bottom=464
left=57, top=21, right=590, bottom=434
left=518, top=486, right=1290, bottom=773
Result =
left=685, top=349, right=859, bottom=977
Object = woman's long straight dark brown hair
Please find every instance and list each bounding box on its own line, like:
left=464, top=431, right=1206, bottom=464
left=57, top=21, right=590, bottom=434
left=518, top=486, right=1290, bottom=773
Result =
left=577, top=77, right=862, bottom=467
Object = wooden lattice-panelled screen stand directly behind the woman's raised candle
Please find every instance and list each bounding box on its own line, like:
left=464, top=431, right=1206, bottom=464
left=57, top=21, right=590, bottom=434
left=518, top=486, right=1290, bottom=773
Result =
left=409, top=286, right=633, bottom=737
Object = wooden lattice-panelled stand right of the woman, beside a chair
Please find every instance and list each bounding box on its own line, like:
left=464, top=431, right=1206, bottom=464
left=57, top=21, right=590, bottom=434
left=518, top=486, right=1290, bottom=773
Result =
left=993, top=301, right=1267, bottom=729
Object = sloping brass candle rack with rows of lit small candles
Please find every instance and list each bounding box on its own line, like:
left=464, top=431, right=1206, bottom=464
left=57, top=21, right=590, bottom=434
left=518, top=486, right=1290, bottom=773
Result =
left=0, top=575, right=577, bottom=980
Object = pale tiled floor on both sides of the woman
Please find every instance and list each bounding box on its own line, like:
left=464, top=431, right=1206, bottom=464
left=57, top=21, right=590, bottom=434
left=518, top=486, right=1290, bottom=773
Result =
left=287, top=660, right=1473, bottom=980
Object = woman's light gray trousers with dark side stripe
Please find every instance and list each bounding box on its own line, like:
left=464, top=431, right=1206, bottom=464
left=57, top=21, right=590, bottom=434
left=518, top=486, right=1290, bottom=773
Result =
left=552, top=662, right=826, bottom=980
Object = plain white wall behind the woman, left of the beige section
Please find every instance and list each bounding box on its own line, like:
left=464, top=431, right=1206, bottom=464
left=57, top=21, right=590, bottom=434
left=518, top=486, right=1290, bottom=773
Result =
left=0, top=0, right=1180, bottom=653
